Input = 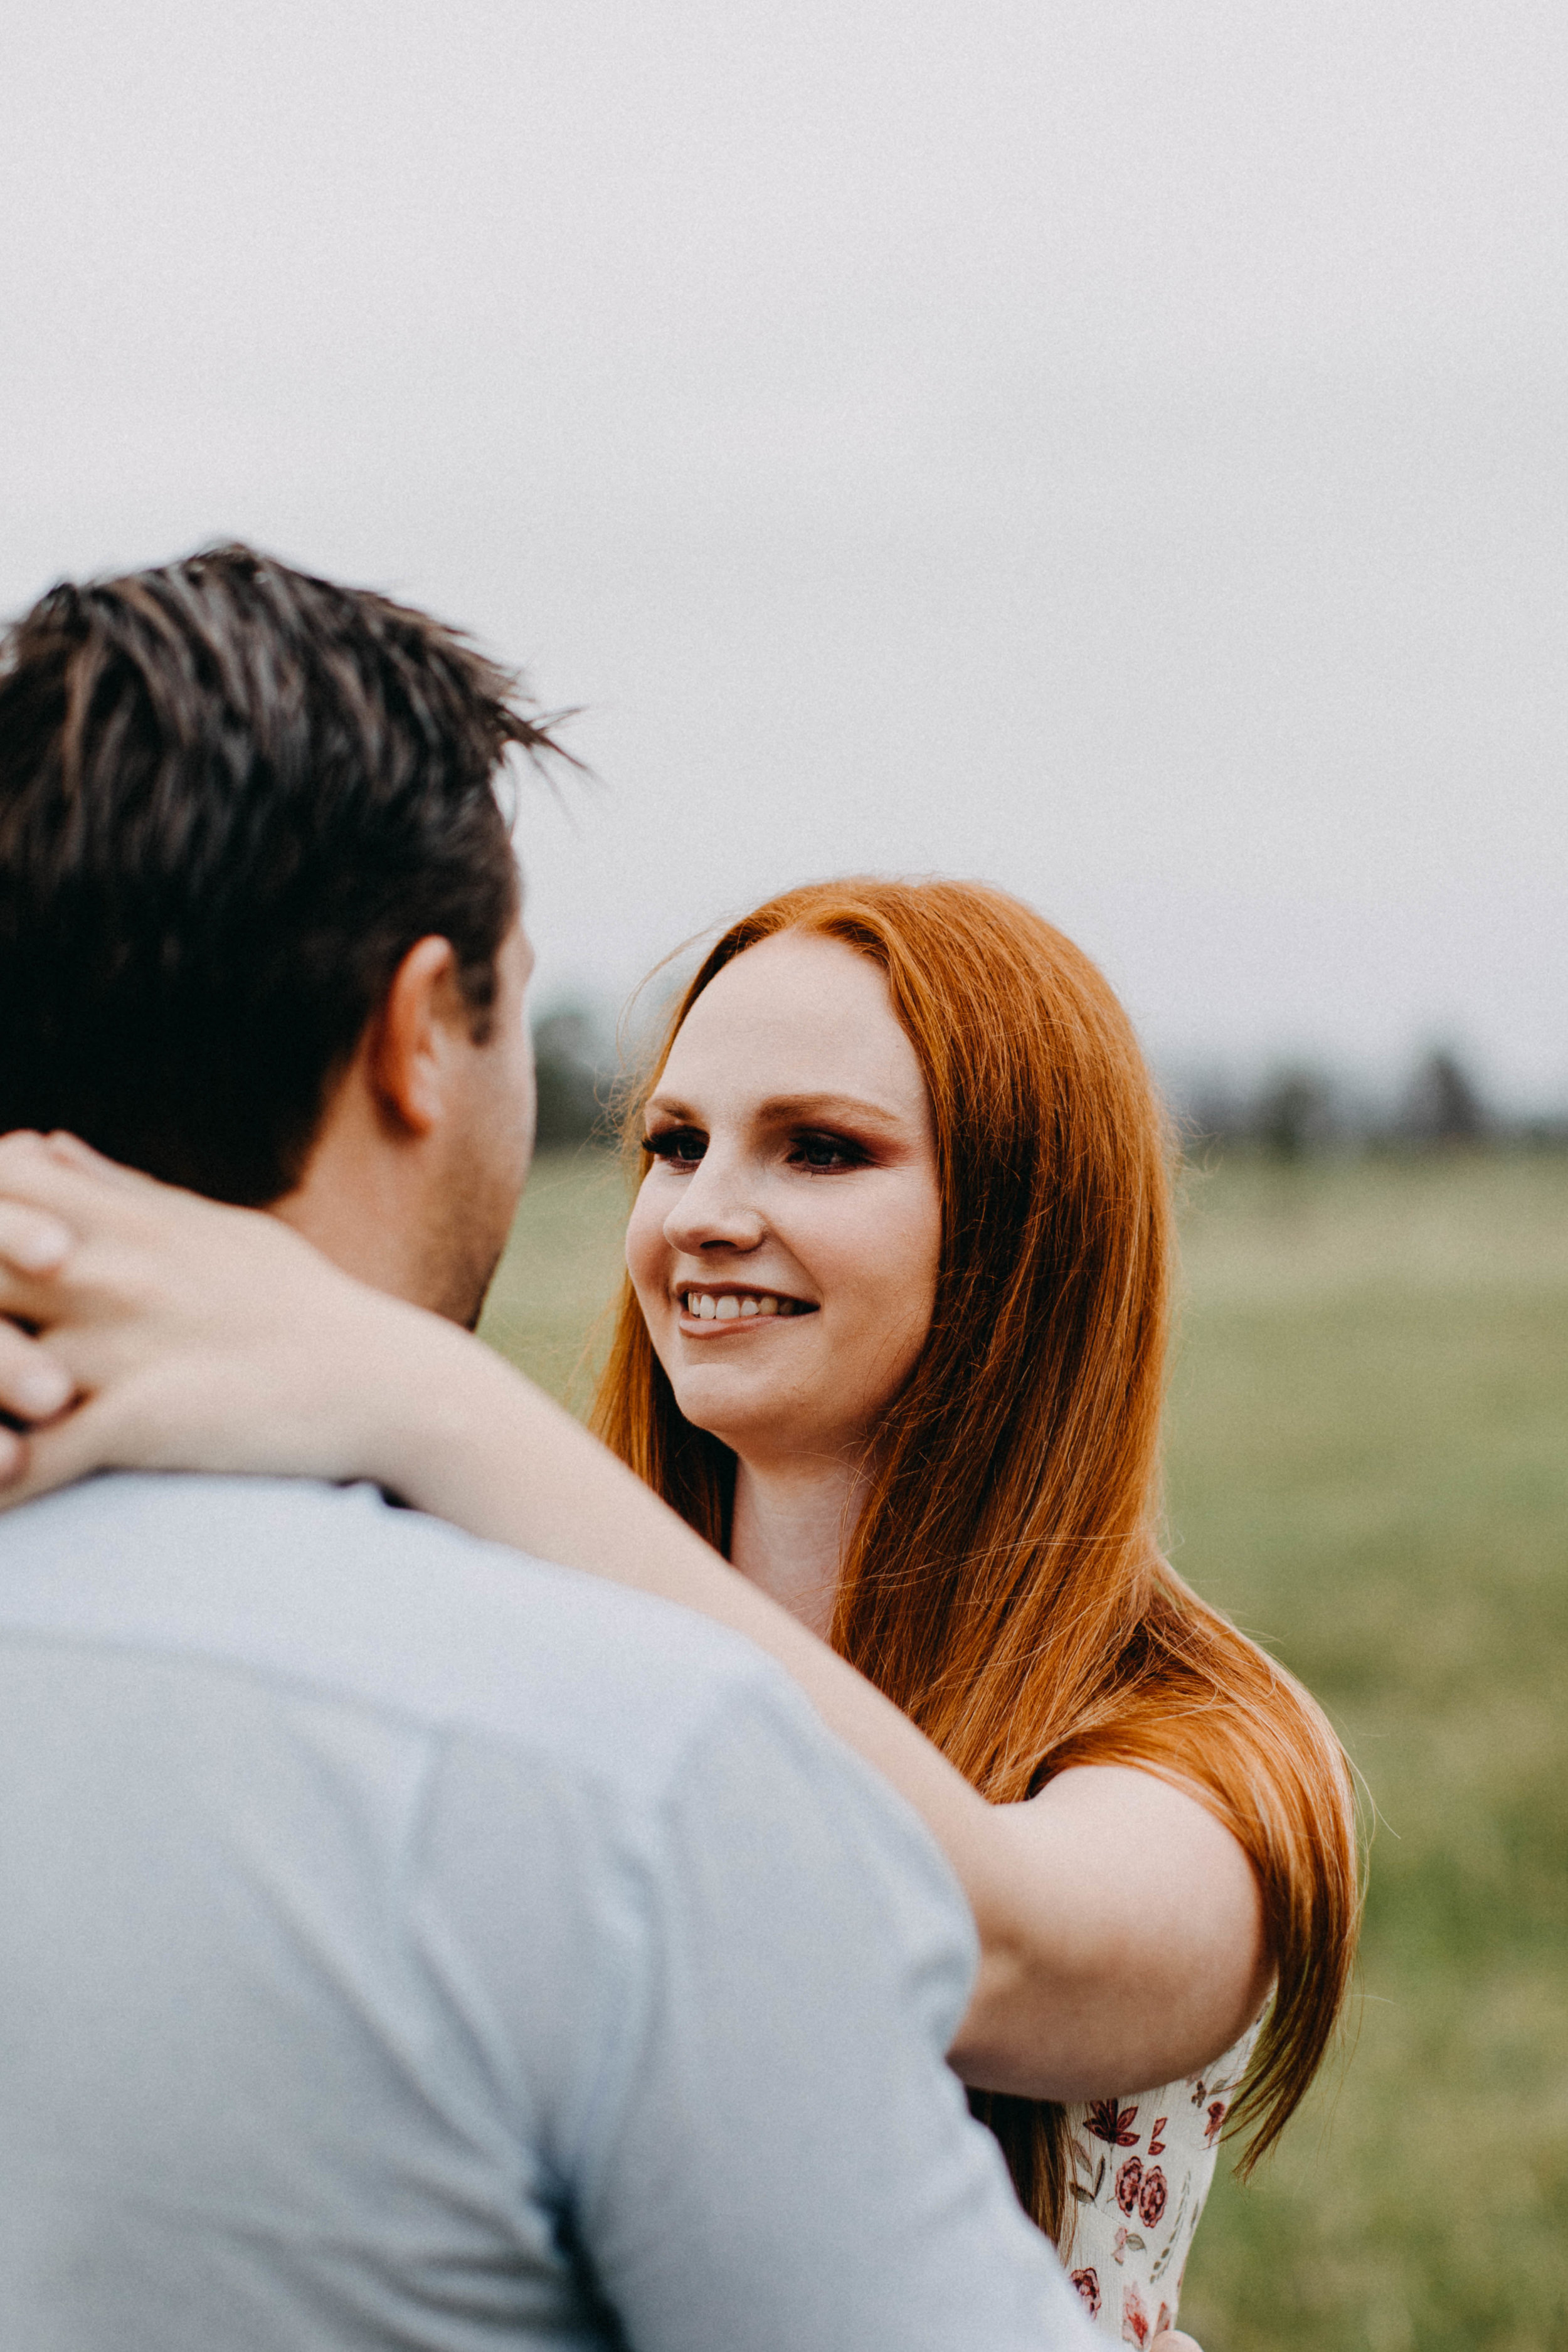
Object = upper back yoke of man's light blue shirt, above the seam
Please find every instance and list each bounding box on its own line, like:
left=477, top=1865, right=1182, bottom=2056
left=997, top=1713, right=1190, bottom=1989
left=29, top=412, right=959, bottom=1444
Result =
left=0, top=1475, right=797, bottom=1794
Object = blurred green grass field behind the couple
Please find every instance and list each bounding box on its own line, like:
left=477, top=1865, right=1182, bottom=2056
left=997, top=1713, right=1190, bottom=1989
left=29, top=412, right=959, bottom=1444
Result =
left=484, top=1155, right=1568, bottom=2352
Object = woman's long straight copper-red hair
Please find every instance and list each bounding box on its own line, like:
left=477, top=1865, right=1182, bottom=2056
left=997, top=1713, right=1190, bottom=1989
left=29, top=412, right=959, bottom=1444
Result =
left=593, top=877, right=1359, bottom=2242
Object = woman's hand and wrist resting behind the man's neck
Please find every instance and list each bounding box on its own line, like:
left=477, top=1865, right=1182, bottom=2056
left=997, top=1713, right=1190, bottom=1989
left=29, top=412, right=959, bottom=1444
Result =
left=0, top=1134, right=472, bottom=1503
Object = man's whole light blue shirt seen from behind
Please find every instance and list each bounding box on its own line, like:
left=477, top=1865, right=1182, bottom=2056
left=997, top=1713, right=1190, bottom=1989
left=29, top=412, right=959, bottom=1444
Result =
left=0, top=1477, right=1091, bottom=2352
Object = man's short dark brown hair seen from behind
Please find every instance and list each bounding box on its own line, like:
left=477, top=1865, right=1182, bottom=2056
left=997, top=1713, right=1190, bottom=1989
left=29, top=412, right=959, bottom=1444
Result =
left=0, top=546, right=573, bottom=1207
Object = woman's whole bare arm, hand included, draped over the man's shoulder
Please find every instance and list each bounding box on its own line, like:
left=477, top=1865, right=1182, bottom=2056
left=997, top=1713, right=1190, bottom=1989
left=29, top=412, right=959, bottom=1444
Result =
left=0, top=1138, right=1267, bottom=2100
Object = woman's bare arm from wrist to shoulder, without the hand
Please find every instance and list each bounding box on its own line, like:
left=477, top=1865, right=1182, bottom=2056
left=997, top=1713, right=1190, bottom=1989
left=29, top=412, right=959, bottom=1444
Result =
left=310, top=1333, right=1267, bottom=2100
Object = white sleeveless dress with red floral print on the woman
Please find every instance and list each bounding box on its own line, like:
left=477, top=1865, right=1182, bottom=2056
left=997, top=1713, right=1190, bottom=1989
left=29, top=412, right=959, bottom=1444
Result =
left=1060, top=2025, right=1258, bottom=2348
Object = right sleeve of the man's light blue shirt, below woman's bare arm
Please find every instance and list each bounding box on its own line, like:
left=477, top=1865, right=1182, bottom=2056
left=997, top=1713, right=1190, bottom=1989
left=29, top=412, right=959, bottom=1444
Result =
left=574, top=1687, right=1093, bottom=2352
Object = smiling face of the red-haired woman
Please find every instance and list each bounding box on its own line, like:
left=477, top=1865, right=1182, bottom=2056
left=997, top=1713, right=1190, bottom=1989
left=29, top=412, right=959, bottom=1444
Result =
left=625, top=931, right=940, bottom=1468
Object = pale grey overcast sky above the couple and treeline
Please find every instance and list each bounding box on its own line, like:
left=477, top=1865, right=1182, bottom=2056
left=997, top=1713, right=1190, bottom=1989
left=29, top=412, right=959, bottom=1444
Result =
left=0, top=0, right=1568, bottom=1101
